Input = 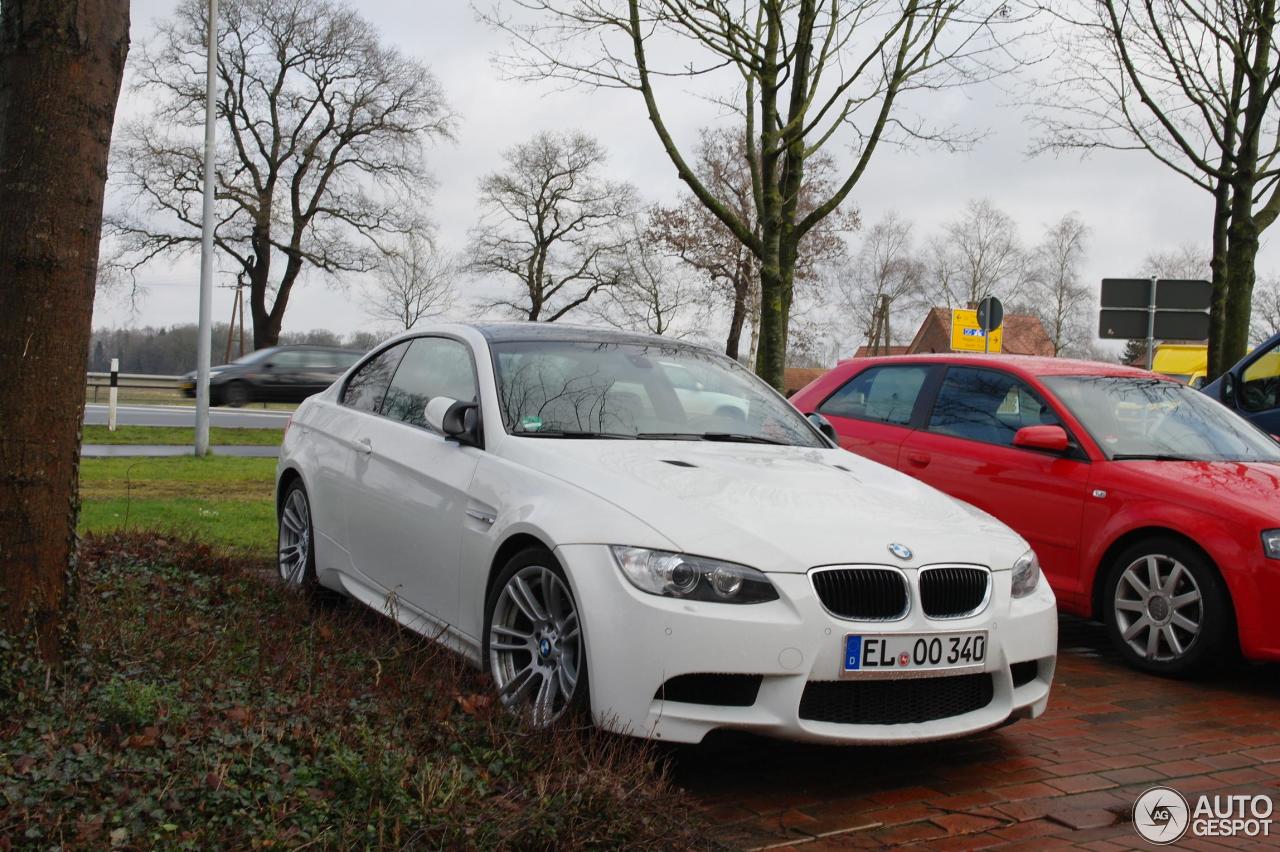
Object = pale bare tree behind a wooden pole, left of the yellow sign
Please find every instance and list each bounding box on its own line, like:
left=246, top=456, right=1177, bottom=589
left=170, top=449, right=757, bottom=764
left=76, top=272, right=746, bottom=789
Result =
left=833, top=212, right=927, bottom=344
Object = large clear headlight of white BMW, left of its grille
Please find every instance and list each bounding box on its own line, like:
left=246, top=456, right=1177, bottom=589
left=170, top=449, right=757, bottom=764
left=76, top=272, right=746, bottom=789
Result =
left=609, top=545, right=778, bottom=604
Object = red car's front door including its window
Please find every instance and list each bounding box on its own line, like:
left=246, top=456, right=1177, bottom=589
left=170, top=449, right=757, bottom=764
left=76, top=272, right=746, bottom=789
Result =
left=899, top=367, right=1089, bottom=596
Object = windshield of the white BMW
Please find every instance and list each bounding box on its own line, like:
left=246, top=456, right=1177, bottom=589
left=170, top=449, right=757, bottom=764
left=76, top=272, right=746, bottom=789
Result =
left=483, top=340, right=826, bottom=446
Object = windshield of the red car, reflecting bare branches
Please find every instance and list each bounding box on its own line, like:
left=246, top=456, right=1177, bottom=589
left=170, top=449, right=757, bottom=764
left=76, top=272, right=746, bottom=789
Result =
left=1044, top=376, right=1280, bottom=462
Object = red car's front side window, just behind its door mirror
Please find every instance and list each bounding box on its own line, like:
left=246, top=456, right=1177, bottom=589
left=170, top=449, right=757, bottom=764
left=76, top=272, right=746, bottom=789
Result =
left=929, top=367, right=1059, bottom=446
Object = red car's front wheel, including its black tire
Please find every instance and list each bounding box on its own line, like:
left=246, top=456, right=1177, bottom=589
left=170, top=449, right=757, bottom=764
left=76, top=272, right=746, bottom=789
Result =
left=1102, top=536, right=1235, bottom=678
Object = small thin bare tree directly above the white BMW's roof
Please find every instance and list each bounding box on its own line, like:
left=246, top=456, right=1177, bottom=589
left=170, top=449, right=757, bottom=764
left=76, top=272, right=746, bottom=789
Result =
left=593, top=225, right=708, bottom=338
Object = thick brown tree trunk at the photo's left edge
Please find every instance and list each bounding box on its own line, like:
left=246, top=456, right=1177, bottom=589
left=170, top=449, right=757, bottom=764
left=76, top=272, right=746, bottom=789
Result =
left=0, top=0, right=129, bottom=661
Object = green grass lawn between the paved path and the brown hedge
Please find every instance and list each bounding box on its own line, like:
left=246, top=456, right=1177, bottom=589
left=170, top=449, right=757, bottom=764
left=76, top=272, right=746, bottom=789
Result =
left=79, top=455, right=275, bottom=555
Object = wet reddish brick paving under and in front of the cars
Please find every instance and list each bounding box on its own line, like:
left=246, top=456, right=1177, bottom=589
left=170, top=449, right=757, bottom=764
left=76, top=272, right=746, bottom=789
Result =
left=671, top=619, right=1280, bottom=852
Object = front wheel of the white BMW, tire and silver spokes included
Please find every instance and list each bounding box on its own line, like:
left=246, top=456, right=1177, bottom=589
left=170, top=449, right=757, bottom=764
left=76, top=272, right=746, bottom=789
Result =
left=484, top=548, right=590, bottom=728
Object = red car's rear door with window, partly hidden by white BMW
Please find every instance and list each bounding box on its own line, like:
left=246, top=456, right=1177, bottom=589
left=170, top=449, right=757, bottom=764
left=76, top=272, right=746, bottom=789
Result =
left=806, top=363, right=933, bottom=467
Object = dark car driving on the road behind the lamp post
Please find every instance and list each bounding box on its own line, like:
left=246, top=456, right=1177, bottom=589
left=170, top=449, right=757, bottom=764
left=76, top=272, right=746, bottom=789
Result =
left=182, top=345, right=364, bottom=406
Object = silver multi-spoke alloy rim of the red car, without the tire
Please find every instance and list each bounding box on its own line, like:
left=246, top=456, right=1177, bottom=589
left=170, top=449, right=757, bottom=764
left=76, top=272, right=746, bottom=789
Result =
left=1114, top=554, right=1204, bottom=661
